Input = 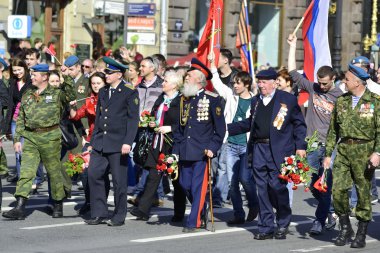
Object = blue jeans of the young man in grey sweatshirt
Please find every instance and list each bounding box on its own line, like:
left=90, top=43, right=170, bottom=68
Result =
left=307, top=146, right=332, bottom=226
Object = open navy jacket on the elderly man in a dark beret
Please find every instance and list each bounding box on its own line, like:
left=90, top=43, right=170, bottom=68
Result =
left=228, top=90, right=307, bottom=169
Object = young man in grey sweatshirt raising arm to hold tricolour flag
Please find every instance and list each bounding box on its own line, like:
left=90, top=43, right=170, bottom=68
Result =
left=288, top=34, right=343, bottom=235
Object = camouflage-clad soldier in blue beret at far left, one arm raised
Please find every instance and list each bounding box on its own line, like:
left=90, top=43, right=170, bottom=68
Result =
left=3, top=64, right=76, bottom=220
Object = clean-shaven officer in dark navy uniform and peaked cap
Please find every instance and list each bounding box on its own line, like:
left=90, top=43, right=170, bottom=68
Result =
left=86, top=57, right=139, bottom=226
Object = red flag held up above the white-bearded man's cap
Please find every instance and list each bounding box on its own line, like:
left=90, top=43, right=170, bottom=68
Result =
left=197, top=0, right=223, bottom=67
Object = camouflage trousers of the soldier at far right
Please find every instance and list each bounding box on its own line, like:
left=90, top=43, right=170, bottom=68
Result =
left=332, top=142, right=374, bottom=221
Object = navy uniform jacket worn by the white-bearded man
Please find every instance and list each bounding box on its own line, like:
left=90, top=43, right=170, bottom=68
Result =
left=173, top=91, right=226, bottom=161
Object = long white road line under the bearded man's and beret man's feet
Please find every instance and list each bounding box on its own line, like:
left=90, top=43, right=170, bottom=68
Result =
left=131, top=220, right=313, bottom=243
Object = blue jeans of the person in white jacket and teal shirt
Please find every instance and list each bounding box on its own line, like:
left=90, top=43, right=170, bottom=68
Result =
left=226, top=143, right=259, bottom=219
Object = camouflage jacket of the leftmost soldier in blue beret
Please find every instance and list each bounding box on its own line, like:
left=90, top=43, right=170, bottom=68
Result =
left=14, top=76, right=76, bottom=142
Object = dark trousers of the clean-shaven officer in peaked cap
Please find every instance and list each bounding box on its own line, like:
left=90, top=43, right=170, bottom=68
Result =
left=88, top=150, right=128, bottom=222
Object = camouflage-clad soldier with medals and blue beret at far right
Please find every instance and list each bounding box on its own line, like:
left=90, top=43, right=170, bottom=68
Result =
left=323, top=64, right=380, bottom=248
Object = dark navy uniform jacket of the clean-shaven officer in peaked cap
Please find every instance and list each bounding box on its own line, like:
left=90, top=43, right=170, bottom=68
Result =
left=90, top=82, right=140, bottom=153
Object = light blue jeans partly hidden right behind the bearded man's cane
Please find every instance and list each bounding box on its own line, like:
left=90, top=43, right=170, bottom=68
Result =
left=212, top=143, right=232, bottom=205
